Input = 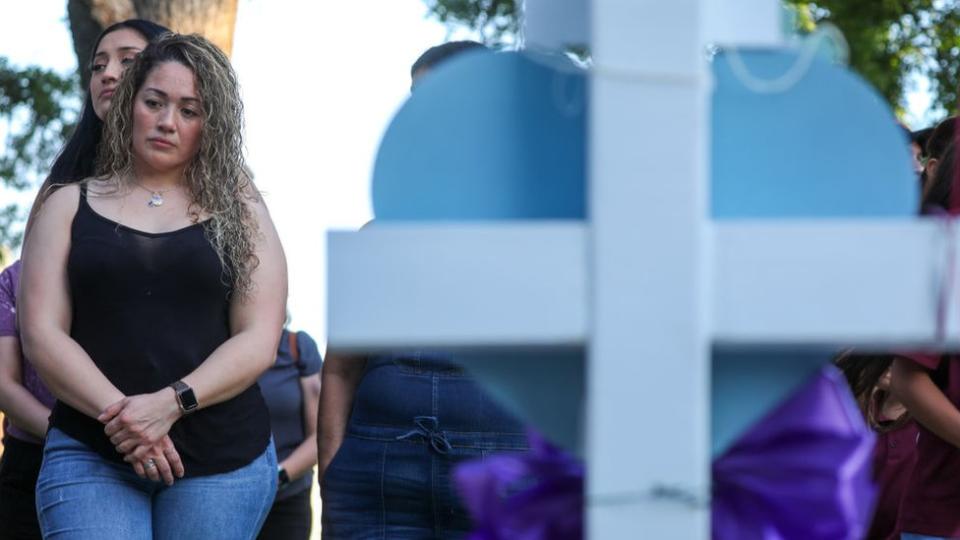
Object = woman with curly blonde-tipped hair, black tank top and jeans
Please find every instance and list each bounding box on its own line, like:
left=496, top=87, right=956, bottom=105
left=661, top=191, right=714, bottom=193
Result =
left=20, top=34, right=286, bottom=540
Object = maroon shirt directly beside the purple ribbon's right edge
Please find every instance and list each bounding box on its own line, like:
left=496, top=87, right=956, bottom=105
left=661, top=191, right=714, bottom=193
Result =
left=867, top=420, right=919, bottom=540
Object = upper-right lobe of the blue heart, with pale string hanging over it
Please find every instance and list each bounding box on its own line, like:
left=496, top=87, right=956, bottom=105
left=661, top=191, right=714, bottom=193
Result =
left=712, top=50, right=919, bottom=219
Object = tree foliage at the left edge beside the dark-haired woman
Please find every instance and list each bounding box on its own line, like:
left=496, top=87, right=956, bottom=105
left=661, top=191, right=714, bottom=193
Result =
left=0, top=57, right=80, bottom=247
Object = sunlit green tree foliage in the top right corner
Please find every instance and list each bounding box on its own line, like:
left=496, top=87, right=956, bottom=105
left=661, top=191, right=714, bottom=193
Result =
left=784, top=0, right=960, bottom=117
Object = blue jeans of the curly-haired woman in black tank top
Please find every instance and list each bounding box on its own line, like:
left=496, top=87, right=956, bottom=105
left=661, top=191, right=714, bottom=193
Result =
left=37, top=429, right=277, bottom=540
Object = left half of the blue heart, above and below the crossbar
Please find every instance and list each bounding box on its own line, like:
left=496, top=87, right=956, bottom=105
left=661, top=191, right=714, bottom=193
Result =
left=372, top=51, right=587, bottom=451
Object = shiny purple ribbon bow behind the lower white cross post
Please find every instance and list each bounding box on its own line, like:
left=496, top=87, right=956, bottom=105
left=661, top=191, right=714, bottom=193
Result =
left=454, top=366, right=876, bottom=540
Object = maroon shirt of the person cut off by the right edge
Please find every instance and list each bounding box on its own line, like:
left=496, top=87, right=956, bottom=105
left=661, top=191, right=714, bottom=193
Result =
left=899, top=354, right=960, bottom=537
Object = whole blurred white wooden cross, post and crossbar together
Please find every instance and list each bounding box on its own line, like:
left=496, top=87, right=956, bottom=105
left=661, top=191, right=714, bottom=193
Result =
left=328, top=0, right=936, bottom=539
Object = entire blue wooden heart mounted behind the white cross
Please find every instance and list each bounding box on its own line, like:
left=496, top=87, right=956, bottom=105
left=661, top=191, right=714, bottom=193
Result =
left=373, top=50, right=917, bottom=453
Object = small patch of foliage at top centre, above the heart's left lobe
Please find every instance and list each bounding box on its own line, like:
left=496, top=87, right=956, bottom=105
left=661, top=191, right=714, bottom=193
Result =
left=424, top=0, right=520, bottom=45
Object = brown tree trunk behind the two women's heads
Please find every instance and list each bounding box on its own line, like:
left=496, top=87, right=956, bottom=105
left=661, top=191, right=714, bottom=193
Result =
left=67, top=0, right=238, bottom=88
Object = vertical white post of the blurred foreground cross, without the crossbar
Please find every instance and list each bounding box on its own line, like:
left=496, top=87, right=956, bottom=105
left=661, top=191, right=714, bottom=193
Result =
left=587, top=0, right=709, bottom=538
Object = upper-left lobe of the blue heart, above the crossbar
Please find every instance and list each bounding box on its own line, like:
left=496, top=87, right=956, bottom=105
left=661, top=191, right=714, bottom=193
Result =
left=373, top=51, right=587, bottom=221
